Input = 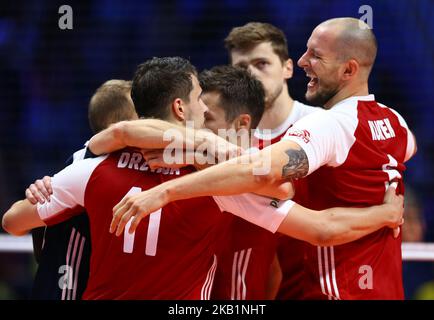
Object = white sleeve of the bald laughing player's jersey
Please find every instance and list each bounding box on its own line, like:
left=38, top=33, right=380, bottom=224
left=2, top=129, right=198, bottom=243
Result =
left=282, top=111, right=357, bottom=174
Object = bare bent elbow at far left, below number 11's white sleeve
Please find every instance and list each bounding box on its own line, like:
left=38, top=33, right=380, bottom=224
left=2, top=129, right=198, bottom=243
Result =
left=2, top=199, right=45, bottom=236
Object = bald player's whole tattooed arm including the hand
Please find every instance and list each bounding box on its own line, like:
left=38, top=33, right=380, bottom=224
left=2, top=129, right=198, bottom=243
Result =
left=110, top=140, right=308, bottom=235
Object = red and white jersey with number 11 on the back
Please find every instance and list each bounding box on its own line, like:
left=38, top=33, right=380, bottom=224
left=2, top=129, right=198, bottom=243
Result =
left=38, top=149, right=221, bottom=299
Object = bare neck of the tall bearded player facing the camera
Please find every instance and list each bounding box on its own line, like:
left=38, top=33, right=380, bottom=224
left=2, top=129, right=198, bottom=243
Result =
left=258, top=84, right=294, bottom=130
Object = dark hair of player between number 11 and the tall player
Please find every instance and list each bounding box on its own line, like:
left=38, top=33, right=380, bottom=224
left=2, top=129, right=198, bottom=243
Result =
left=199, top=65, right=265, bottom=129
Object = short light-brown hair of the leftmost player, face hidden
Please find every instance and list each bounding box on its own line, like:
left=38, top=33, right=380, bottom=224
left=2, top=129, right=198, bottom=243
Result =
left=88, top=80, right=135, bottom=133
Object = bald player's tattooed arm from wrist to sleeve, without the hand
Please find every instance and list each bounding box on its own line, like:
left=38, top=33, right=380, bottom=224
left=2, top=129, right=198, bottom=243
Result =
left=162, top=141, right=302, bottom=202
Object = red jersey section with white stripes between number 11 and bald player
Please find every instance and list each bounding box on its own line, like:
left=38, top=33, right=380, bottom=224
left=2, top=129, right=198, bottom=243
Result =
left=212, top=212, right=274, bottom=300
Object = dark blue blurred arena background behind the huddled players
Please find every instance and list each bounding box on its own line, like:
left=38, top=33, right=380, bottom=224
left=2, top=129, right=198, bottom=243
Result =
left=0, top=0, right=434, bottom=298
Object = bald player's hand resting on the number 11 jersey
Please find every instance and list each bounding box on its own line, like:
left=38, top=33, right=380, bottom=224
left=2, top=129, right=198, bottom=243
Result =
left=110, top=185, right=170, bottom=237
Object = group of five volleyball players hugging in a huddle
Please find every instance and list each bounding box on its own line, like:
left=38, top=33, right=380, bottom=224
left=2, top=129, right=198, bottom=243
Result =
left=2, top=18, right=417, bottom=300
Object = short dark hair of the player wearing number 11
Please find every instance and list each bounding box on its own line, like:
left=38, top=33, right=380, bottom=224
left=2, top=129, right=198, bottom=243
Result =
left=131, top=57, right=197, bottom=120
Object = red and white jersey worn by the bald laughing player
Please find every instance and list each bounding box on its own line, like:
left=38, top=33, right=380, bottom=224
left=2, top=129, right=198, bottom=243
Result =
left=283, top=95, right=415, bottom=299
